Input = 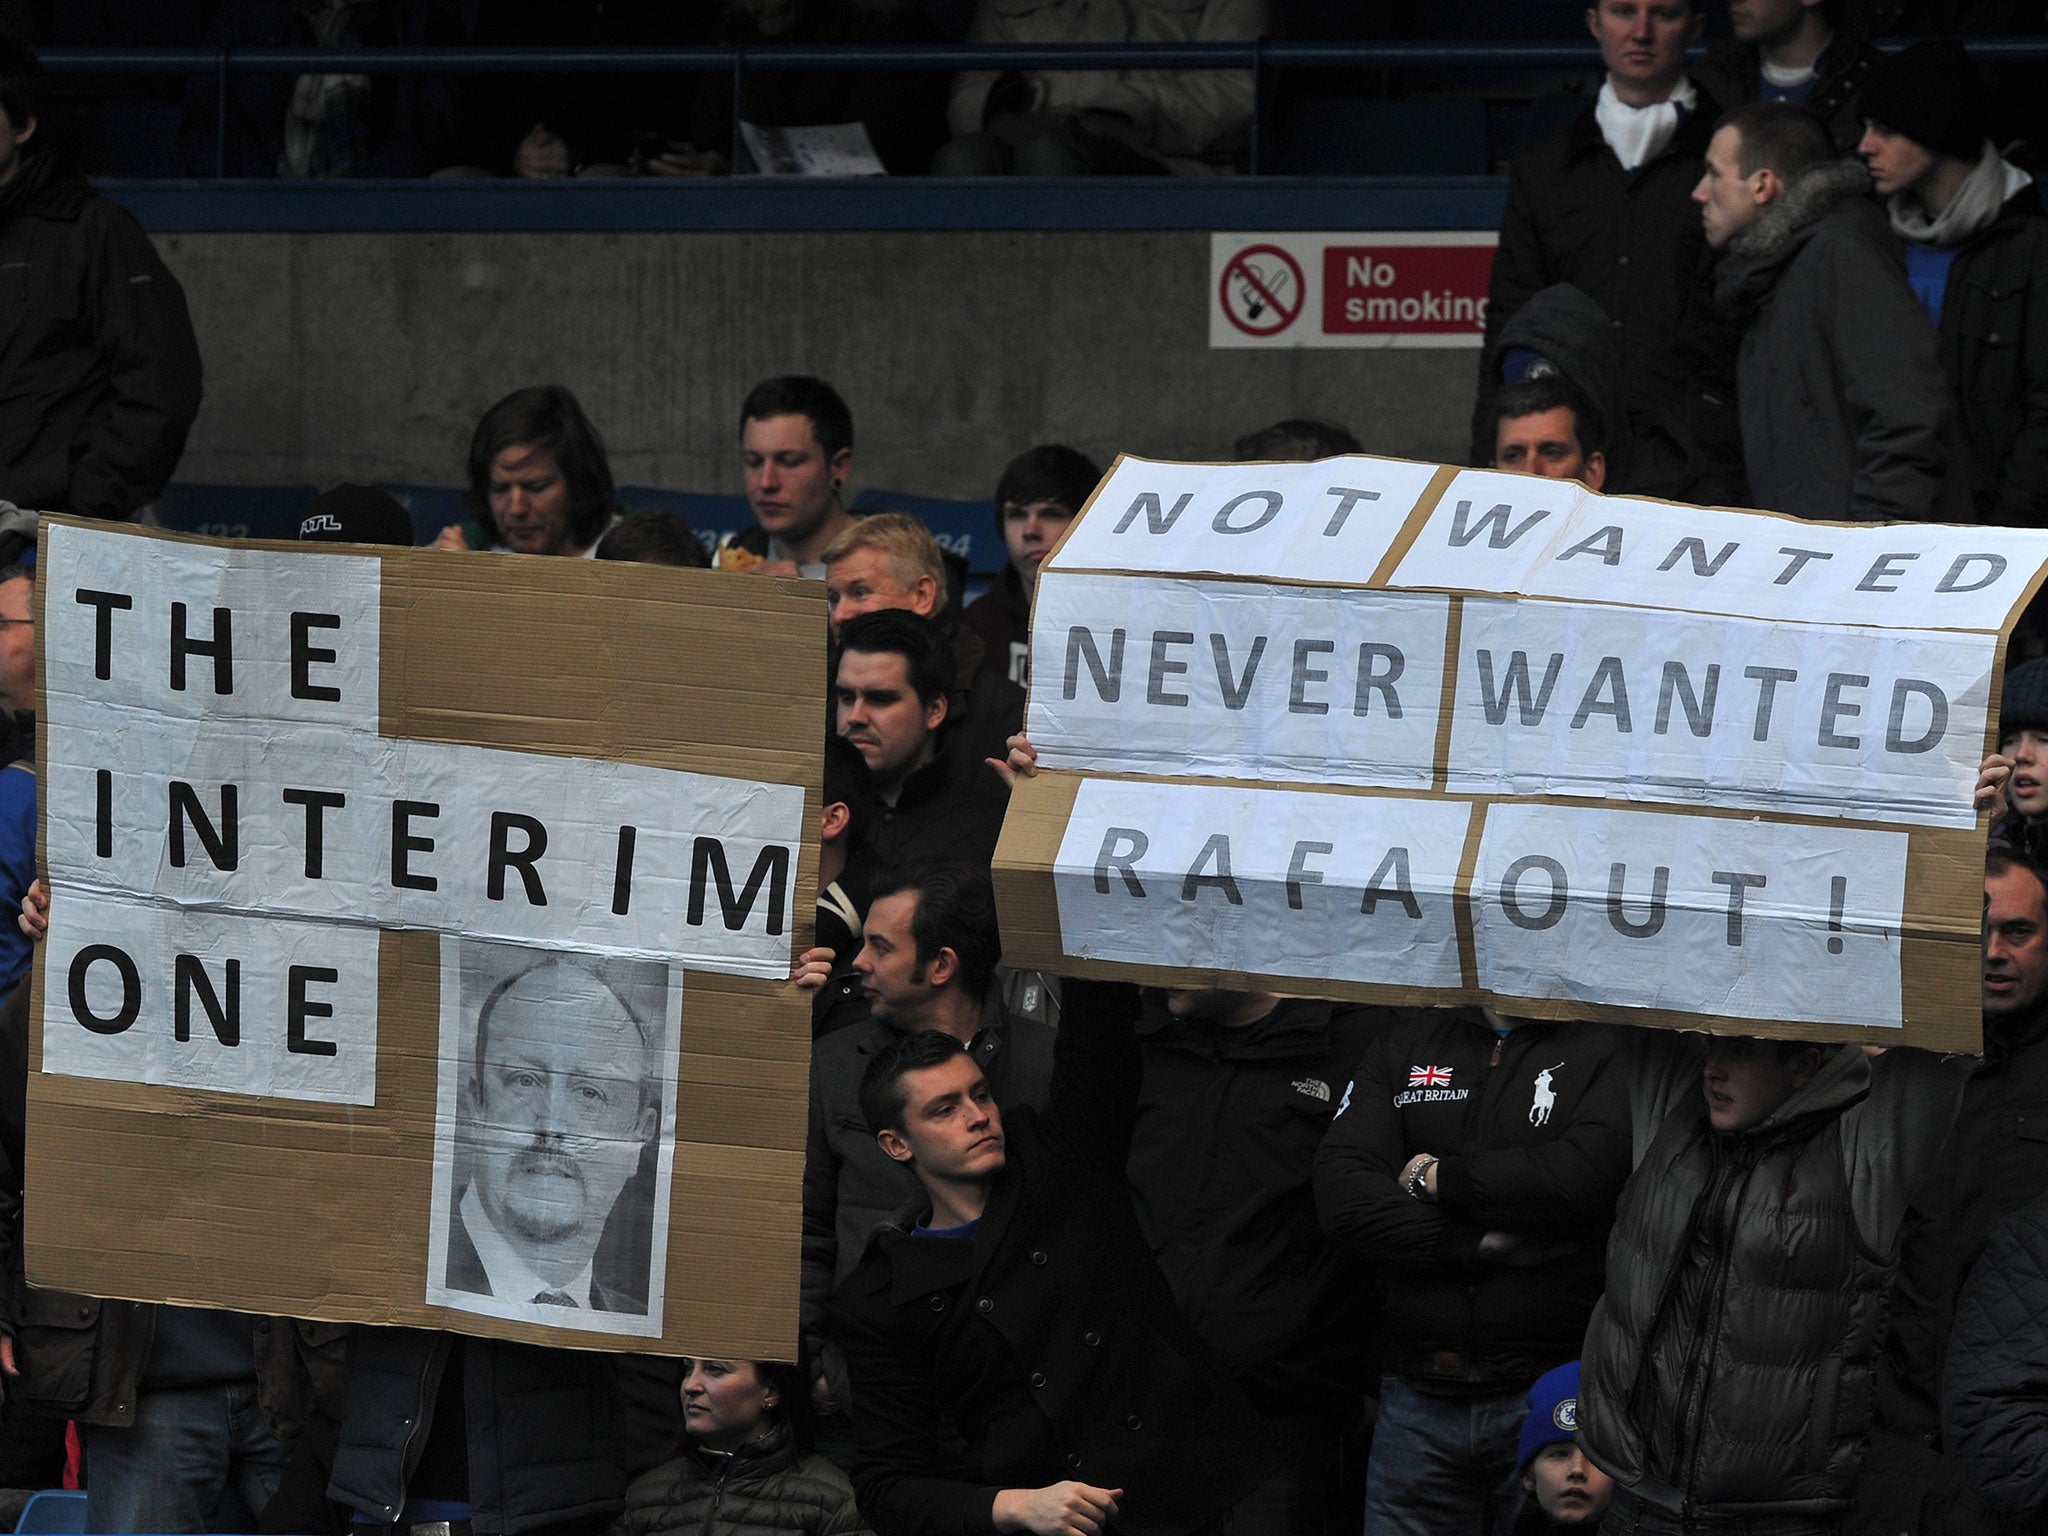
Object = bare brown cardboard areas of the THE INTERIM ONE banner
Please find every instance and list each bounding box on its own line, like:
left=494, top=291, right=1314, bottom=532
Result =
left=27, top=520, right=825, bottom=1358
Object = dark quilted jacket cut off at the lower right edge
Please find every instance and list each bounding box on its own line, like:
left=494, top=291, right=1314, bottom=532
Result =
left=1942, top=1198, right=2048, bottom=1530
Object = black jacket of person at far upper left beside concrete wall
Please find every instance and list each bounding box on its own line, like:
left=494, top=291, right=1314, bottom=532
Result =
left=0, top=152, right=199, bottom=518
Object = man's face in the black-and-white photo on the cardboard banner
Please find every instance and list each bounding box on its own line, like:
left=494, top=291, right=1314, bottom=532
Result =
left=465, top=965, right=659, bottom=1276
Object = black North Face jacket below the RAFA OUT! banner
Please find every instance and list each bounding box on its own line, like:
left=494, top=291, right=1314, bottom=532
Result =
left=1128, top=993, right=1380, bottom=1417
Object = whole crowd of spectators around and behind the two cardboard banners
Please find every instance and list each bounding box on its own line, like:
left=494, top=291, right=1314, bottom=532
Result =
left=0, top=0, right=2048, bottom=1536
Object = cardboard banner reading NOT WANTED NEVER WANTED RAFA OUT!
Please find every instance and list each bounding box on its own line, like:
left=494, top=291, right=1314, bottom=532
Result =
left=995, top=455, right=2048, bottom=1049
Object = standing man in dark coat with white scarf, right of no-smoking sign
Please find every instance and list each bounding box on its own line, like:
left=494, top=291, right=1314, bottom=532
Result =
left=1470, top=0, right=1741, bottom=500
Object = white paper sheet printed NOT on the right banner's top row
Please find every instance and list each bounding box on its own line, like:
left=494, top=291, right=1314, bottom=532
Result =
left=1047, top=455, right=1436, bottom=586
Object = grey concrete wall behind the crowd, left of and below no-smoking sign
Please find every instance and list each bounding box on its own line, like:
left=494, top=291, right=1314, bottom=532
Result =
left=158, top=231, right=1477, bottom=496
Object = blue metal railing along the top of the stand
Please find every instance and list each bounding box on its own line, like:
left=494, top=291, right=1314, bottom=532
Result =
left=39, top=37, right=2048, bottom=178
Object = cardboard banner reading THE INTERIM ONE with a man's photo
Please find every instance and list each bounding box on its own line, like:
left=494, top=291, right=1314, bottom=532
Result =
left=27, top=518, right=825, bottom=1358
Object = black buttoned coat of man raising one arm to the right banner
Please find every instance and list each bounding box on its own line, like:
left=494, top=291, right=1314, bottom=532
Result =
left=831, top=977, right=1272, bottom=1536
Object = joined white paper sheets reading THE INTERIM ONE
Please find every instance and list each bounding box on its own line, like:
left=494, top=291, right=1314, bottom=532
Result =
left=39, top=524, right=803, bottom=1104
